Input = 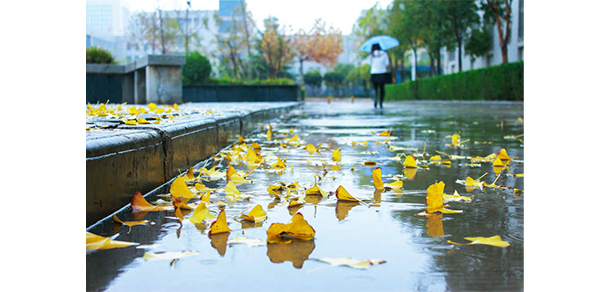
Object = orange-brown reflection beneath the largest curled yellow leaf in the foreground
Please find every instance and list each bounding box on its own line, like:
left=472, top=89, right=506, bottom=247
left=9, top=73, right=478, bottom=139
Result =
left=267, top=239, right=316, bottom=269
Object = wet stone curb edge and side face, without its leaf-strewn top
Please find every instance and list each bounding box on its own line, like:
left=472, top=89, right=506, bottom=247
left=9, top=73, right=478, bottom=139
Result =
left=86, top=102, right=304, bottom=226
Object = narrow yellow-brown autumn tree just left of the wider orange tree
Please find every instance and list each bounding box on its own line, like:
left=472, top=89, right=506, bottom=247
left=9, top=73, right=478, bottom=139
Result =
left=259, top=17, right=294, bottom=78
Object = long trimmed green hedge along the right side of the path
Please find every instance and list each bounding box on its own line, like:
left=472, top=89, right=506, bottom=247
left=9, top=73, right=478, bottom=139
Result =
left=385, top=61, right=524, bottom=101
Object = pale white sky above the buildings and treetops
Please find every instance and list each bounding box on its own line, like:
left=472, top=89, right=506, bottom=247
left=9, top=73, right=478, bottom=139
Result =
left=124, top=0, right=392, bottom=34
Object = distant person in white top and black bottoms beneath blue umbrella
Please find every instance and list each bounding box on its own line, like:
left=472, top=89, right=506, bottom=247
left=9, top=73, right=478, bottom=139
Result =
left=362, top=44, right=392, bottom=108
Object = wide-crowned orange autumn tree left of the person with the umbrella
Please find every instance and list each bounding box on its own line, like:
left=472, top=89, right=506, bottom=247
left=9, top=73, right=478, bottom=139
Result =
left=292, top=19, right=343, bottom=84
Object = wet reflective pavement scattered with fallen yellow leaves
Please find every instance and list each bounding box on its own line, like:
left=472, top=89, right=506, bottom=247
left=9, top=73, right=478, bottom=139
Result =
left=86, top=100, right=525, bottom=291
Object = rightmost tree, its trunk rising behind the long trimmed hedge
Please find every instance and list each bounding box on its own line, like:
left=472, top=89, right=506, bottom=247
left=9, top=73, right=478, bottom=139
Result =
left=482, top=0, right=513, bottom=63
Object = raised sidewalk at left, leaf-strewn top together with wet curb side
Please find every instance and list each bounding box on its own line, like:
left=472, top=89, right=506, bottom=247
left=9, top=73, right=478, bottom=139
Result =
left=86, top=102, right=303, bottom=226
